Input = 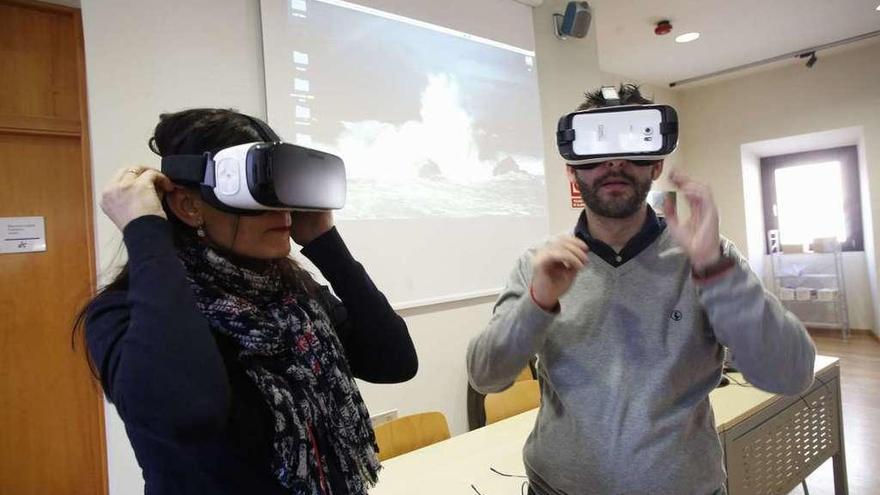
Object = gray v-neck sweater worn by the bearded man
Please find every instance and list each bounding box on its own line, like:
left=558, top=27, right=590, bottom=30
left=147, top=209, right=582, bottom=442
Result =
left=467, top=231, right=815, bottom=495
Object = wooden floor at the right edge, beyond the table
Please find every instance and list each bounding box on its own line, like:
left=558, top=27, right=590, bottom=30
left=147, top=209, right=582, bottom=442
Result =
left=789, top=331, right=880, bottom=495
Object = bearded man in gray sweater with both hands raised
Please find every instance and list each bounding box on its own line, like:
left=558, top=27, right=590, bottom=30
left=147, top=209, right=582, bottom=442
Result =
left=467, top=85, right=815, bottom=495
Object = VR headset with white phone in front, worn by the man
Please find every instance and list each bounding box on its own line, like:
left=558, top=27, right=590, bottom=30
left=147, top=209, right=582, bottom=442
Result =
left=556, top=98, right=678, bottom=168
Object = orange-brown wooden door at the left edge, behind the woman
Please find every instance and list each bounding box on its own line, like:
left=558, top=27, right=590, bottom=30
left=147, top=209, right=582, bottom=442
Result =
left=0, top=0, right=107, bottom=495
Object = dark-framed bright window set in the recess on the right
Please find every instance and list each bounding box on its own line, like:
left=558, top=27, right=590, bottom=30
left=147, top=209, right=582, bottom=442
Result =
left=761, top=146, right=864, bottom=251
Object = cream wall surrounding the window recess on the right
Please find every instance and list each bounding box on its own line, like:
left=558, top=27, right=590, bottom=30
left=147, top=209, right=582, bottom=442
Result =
left=677, top=42, right=880, bottom=338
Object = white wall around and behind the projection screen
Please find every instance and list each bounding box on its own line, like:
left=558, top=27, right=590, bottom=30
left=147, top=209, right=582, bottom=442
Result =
left=82, top=0, right=599, bottom=495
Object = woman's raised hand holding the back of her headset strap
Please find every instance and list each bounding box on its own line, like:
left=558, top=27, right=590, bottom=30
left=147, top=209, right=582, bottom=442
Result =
left=101, top=166, right=174, bottom=231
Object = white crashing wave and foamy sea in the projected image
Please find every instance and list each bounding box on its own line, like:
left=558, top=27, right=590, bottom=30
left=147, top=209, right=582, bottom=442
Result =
left=334, top=74, right=546, bottom=219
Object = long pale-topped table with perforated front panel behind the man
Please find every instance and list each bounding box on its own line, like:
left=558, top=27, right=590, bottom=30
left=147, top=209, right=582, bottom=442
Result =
left=370, top=356, right=848, bottom=495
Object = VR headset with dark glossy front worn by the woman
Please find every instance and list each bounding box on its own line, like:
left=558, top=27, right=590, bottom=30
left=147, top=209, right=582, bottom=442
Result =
left=162, top=116, right=346, bottom=215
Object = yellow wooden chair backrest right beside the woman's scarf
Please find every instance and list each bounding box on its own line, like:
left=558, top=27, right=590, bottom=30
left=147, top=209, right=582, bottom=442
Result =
left=374, top=412, right=450, bottom=461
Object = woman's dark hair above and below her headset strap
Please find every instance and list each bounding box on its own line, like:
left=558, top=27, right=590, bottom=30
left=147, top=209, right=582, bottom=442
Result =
left=72, top=108, right=318, bottom=360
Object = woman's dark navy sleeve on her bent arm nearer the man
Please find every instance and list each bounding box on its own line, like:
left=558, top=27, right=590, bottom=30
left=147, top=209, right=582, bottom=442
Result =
left=302, top=227, right=419, bottom=383
